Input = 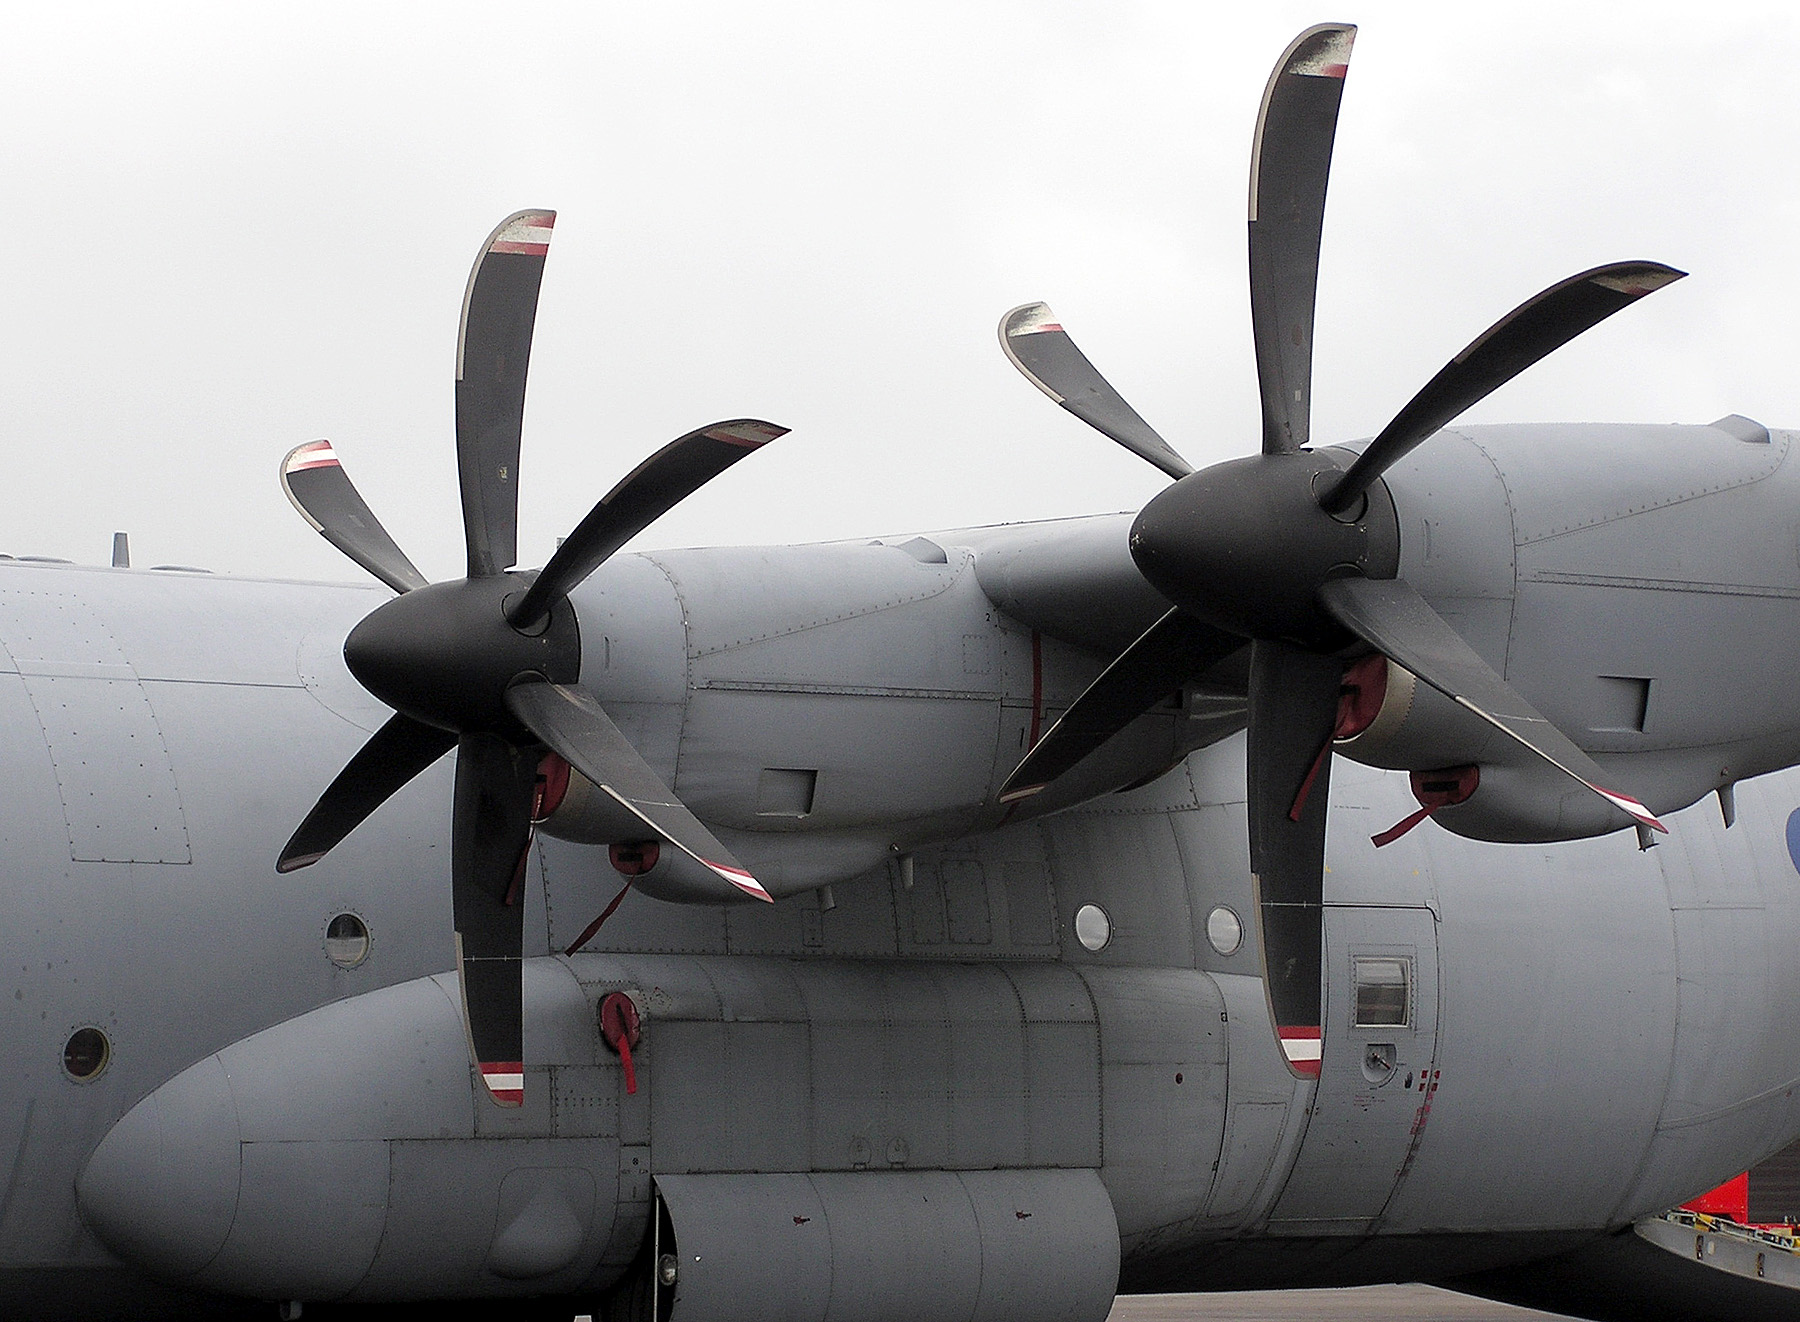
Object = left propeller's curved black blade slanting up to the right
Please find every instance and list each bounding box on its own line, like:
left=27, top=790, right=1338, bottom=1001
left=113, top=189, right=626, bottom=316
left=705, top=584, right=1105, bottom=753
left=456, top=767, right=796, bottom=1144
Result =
left=506, top=418, right=788, bottom=629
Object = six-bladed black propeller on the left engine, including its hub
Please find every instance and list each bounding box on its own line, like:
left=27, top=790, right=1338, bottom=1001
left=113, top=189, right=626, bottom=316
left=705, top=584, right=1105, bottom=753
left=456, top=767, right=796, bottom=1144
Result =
left=275, top=211, right=787, bottom=1106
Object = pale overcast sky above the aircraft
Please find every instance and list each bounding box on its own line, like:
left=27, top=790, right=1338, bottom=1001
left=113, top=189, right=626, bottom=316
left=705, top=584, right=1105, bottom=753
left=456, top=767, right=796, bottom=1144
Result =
left=0, top=0, right=1800, bottom=578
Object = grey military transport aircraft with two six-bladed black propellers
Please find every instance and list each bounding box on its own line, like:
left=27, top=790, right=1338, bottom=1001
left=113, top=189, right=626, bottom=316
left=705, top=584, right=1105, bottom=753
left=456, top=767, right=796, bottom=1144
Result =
left=0, top=25, right=1800, bottom=1322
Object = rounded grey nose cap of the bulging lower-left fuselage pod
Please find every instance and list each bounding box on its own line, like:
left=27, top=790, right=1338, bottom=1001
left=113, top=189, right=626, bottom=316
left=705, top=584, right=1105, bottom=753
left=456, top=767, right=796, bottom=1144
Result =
left=76, top=1055, right=239, bottom=1277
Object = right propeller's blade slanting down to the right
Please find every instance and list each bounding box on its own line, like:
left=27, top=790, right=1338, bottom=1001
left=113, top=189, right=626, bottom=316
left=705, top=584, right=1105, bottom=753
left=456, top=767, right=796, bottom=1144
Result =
left=1319, top=578, right=1669, bottom=832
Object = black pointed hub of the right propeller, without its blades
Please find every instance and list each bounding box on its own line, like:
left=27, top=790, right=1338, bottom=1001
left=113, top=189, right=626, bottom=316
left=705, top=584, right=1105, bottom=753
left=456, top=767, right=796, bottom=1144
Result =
left=1130, top=450, right=1400, bottom=650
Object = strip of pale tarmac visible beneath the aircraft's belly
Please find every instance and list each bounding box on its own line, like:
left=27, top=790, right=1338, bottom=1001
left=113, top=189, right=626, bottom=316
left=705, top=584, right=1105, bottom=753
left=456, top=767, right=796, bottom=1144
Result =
left=1107, top=1286, right=1566, bottom=1322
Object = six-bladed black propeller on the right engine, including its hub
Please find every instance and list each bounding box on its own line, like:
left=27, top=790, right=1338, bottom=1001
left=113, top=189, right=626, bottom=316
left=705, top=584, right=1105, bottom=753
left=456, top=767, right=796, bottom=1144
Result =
left=1001, top=23, right=1681, bottom=1075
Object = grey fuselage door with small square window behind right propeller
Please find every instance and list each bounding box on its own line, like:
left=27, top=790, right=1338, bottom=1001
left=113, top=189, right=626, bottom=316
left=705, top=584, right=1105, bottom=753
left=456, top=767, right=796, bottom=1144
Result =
left=1273, top=904, right=1438, bottom=1234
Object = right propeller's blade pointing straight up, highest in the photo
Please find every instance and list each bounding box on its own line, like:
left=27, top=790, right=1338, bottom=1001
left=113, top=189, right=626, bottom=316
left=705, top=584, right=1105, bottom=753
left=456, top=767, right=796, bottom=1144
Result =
left=1249, top=23, right=1355, bottom=454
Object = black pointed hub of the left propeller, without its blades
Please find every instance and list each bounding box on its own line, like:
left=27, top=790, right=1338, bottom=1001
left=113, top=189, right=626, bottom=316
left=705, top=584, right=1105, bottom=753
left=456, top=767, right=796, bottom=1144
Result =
left=344, top=575, right=581, bottom=742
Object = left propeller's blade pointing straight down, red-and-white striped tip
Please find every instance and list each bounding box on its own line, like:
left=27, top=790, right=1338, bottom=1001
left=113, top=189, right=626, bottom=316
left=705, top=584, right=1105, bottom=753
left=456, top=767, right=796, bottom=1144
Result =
left=450, top=735, right=536, bottom=1106
